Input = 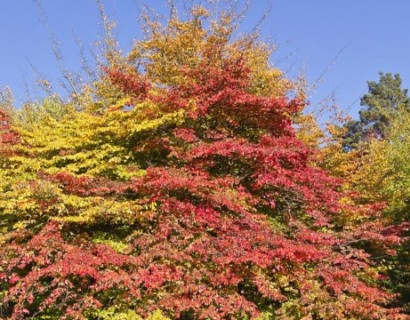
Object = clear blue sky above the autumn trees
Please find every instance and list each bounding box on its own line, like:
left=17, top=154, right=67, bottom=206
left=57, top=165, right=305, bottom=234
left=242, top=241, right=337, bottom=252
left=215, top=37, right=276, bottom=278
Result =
left=0, top=0, right=410, bottom=116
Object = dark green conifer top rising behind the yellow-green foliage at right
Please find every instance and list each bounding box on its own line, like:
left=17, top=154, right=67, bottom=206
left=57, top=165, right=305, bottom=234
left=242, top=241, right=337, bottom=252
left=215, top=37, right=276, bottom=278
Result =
left=344, top=73, right=410, bottom=150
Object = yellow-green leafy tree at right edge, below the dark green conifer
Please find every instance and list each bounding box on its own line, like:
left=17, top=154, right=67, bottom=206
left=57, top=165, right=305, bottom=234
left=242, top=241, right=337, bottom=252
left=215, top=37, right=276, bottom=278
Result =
left=346, top=110, right=410, bottom=312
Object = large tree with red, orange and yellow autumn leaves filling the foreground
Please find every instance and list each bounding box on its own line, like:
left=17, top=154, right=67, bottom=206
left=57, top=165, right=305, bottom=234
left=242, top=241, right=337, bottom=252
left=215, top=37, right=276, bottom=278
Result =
left=0, top=3, right=406, bottom=319
